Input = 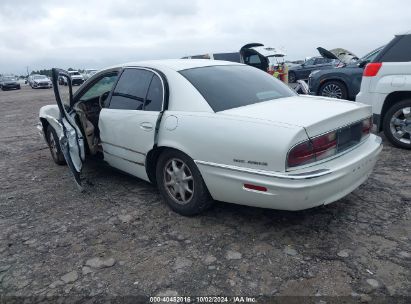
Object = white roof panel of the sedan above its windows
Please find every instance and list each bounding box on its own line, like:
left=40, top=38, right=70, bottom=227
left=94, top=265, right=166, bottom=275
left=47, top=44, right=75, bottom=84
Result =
left=107, top=59, right=244, bottom=71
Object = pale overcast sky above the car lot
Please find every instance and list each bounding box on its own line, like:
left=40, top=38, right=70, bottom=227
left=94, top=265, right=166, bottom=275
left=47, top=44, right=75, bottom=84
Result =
left=0, top=0, right=411, bottom=74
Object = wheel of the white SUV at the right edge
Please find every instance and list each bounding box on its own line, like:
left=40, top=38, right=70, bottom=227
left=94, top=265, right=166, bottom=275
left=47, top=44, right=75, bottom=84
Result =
left=383, top=100, right=411, bottom=149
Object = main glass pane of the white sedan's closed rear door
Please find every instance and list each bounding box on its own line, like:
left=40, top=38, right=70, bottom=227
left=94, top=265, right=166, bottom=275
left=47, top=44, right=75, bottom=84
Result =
left=109, top=69, right=154, bottom=110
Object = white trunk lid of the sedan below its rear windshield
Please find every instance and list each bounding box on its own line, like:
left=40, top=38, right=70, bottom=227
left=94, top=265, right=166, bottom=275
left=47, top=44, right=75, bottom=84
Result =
left=217, top=96, right=372, bottom=137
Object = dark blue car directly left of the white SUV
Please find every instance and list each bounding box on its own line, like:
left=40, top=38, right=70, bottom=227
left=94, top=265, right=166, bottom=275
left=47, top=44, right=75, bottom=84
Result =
left=308, top=46, right=383, bottom=100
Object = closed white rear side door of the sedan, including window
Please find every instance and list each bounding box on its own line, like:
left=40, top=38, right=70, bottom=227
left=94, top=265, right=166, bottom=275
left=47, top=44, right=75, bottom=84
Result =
left=99, top=68, right=165, bottom=180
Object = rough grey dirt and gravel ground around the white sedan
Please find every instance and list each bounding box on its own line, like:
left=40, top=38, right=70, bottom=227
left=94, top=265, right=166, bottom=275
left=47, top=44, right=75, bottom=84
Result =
left=0, top=86, right=411, bottom=302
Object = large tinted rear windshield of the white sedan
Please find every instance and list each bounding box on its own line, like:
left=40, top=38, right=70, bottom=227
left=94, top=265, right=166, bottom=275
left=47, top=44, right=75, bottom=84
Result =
left=180, top=65, right=296, bottom=112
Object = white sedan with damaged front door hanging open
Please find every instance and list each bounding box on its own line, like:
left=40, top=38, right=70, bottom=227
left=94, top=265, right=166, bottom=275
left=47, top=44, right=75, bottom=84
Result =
left=39, top=60, right=382, bottom=215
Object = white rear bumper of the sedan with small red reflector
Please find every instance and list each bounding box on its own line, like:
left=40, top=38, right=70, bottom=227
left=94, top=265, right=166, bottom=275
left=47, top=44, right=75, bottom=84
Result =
left=196, top=135, right=382, bottom=210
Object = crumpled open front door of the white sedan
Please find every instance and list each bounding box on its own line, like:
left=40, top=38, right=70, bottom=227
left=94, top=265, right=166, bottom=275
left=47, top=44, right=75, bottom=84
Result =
left=52, top=68, right=85, bottom=189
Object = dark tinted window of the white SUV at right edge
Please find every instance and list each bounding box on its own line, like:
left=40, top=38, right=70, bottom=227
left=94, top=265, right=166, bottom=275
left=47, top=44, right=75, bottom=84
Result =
left=375, top=35, right=411, bottom=62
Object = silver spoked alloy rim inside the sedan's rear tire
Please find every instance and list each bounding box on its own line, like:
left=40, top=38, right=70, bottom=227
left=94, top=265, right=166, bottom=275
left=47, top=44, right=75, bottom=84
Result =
left=163, top=158, right=194, bottom=205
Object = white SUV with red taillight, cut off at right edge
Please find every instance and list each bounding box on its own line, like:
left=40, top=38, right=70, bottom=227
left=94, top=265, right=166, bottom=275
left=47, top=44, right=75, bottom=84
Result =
left=356, top=31, right=411, bottom=149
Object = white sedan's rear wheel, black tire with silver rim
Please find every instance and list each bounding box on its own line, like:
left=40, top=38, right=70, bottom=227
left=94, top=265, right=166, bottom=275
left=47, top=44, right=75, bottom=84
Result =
left=156, top=149, right=213, bottom=216
